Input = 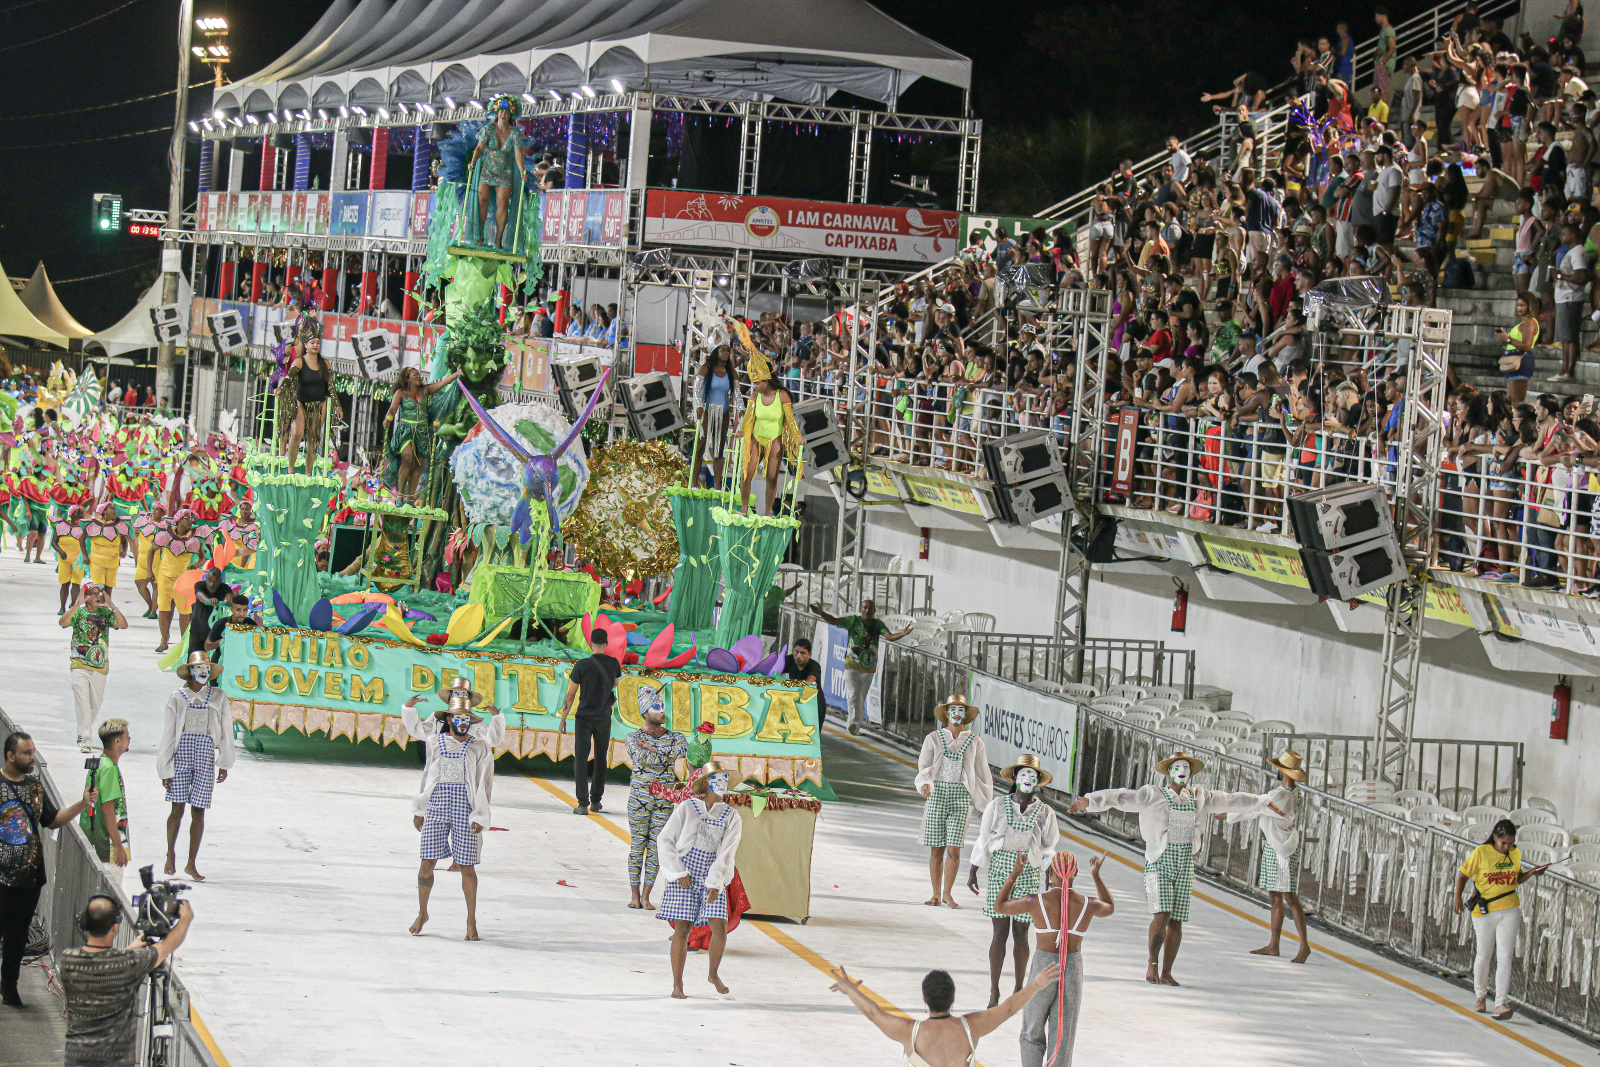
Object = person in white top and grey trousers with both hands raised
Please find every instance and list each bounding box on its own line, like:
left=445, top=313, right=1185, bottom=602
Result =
left=995, top=851, right=1117, bottom=1067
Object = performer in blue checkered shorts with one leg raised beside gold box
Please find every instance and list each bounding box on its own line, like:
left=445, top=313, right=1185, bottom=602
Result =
left=656, top=760, right=744, bottom=1000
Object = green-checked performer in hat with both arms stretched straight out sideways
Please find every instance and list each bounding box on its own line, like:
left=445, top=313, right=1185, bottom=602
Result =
left=1067, top=752, right=1283, bottom=985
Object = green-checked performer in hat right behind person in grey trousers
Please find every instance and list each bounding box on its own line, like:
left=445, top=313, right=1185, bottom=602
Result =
left=966, top=753, right=1059, bottom=1008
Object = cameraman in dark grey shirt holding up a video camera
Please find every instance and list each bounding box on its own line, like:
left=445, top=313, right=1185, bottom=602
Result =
left=61, top=896, right=195, bottom=1067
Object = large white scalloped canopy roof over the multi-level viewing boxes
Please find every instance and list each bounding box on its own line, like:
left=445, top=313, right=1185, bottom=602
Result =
left=214, top=0, right=971, bottom=115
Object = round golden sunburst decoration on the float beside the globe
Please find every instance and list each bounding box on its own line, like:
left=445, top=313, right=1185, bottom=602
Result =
left=562, top=442, right=686, bottom=579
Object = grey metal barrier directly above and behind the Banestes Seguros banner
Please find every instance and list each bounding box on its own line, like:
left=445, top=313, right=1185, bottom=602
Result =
left=944, top=632, right=1195, bottom=699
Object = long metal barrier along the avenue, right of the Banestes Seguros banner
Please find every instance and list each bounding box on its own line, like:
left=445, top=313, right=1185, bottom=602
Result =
left=1077, top=707, right=1600, bottom=1038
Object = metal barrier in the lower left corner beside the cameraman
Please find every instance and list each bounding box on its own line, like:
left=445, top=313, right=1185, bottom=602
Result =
left=0, top=709, right=218, bottom=1067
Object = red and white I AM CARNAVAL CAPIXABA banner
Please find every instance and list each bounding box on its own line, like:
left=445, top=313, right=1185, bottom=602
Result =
left=645, top=189, right=960, bottom=262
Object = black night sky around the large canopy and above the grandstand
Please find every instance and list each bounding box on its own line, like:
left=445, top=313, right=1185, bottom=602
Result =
left=0, top=0, right=1429, bottom=330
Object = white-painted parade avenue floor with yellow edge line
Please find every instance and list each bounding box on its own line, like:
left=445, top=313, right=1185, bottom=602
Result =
left=0, top=547, right=1595, bottom=1067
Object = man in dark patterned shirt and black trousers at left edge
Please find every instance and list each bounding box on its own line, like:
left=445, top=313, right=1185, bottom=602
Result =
left=0, top=729, right=94, bottom=1008
